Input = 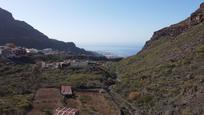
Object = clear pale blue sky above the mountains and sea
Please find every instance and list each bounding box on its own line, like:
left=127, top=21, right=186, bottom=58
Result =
left=0, top=0, right=203, bottom=45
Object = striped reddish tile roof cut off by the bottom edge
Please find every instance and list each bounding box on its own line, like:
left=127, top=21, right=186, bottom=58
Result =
left=54, top=107, right=79, bottom=115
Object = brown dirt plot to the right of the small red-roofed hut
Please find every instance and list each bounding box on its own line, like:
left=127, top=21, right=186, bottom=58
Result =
left=66, top=92, right=119, bottom=115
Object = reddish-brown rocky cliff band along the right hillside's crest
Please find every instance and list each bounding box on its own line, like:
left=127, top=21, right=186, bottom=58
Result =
left=143, top=3, right=204, bottom=49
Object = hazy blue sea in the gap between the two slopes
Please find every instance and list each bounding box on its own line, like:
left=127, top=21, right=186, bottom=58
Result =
left=79, top=45, right=143, bottom=57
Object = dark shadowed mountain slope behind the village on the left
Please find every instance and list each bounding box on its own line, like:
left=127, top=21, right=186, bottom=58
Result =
left=0, top=8, right=90, bottom=54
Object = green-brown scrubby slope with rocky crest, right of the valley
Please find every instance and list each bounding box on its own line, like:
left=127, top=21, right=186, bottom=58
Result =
left=113, top=3, right=204, bottom=115
